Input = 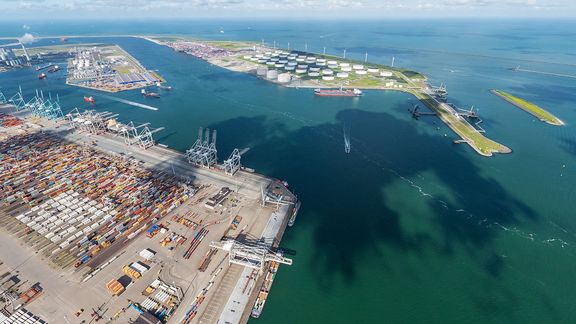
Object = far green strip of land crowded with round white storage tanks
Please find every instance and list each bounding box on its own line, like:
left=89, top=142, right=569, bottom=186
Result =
left=164, top=40, right=412, bottom=89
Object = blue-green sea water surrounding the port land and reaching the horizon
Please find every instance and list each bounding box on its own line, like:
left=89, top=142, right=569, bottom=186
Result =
left=0, top=21, right=576, bottom=323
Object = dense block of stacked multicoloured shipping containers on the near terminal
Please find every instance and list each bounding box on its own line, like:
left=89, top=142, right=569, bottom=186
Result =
left=0, top=133, right=194, bottom=268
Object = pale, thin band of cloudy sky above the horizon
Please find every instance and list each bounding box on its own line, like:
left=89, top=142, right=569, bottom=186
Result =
left=0, top=0, right=576, bottom=19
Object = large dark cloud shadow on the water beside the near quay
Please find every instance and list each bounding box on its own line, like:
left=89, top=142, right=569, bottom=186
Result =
left=190, top=107, right=537, bottom=289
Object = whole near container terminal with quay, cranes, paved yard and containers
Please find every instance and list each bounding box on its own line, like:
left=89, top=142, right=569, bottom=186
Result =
left=0, top=87, right=300, bottom=323
